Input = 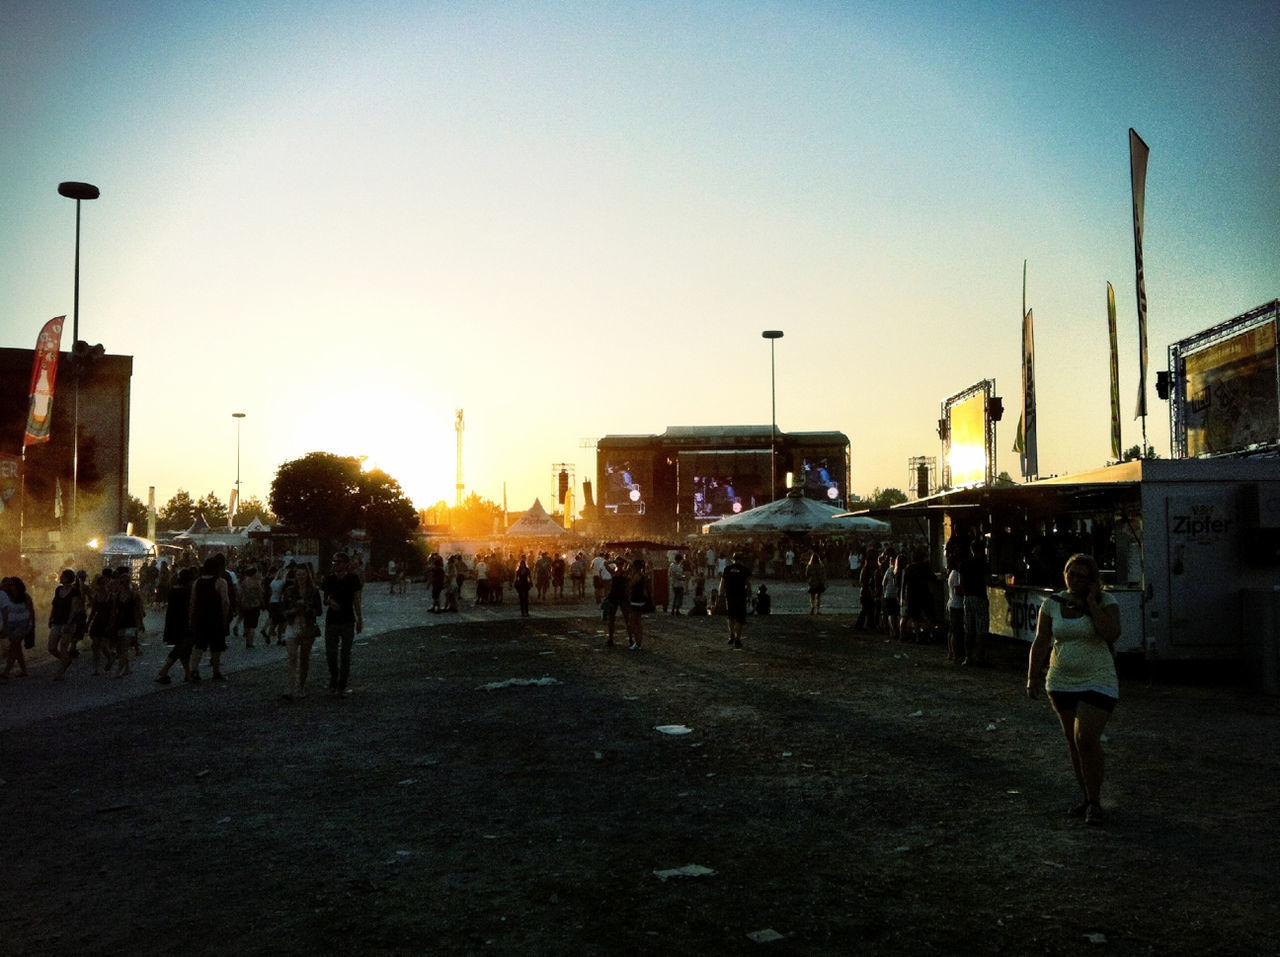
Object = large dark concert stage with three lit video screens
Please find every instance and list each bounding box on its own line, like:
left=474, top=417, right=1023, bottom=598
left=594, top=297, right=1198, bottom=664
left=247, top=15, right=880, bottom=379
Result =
left=595, top=425, right=850, bottom=536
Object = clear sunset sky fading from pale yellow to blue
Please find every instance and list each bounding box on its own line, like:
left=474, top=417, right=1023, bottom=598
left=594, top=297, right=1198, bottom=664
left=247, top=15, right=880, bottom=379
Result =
left=0, top=0, right=1280, bottom=510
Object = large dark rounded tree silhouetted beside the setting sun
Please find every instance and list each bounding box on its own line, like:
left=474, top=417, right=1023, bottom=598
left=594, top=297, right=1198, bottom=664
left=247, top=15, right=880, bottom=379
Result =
left=270, top=452, right=417, bottom=564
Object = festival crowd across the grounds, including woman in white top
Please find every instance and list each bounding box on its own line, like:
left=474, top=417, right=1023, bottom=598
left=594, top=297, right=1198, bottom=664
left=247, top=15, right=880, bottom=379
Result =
left=0, top=536, right=1120, bottom=824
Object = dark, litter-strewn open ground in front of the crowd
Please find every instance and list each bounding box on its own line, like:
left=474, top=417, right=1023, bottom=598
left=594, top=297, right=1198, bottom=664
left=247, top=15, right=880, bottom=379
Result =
left=0, top=591, right=1280, bottom=956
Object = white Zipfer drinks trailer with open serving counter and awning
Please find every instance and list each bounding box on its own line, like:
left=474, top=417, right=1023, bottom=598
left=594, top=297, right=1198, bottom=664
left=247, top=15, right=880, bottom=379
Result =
left=892, top=458, right=1280, bottom=660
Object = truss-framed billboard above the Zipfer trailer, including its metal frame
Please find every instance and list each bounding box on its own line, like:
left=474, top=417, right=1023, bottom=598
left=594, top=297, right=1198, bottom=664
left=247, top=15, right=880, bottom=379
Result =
left=1172, top=299, right=1280, bottom=458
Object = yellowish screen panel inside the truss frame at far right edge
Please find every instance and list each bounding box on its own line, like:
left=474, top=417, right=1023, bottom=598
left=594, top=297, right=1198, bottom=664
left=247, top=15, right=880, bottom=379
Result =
left=1180, top=320, right=1280, bottom=457
